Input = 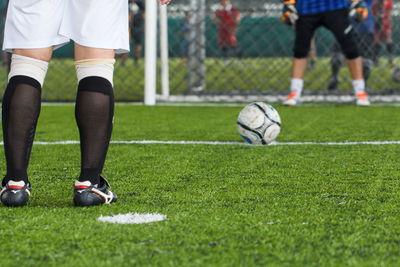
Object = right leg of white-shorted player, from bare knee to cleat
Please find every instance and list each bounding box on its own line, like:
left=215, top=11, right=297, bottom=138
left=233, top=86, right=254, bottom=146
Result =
left=74, top=44, right=116, bottom=206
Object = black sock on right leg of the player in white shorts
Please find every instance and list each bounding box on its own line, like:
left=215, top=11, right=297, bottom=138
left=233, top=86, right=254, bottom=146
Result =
left=75, top=77, right=114, bottom=184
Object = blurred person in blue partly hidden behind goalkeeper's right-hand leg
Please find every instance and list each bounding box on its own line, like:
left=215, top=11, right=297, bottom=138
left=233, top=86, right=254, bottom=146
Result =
left=327, top=0, right=374, bottom=90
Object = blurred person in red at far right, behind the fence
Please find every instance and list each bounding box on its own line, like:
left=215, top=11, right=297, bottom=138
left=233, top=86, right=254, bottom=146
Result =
left=373, top=0, right=393, bottom=65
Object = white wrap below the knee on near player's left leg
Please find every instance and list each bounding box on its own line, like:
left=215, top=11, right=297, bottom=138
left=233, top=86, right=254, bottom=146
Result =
left=8, top=54, right=49, bottom=87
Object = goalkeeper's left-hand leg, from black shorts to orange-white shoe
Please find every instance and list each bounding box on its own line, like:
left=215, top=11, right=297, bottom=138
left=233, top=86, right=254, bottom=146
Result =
left=283, top=14, right=320, bottom=106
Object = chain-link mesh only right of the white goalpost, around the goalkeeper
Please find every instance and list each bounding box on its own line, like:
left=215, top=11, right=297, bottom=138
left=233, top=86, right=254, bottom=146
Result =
left=169, top=0, right=400, bottom=101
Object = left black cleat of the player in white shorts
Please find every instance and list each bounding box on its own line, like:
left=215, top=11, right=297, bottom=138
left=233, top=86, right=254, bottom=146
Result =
left=0, top=180, right=32, bottom=207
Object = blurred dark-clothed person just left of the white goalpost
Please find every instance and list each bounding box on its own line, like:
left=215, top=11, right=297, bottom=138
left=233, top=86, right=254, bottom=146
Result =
left=129, top=0, right=145, bottom=63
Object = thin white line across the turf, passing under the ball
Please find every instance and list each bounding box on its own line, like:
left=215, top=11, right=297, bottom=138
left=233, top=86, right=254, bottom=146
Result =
left=5, top=140, right=400, bottom=146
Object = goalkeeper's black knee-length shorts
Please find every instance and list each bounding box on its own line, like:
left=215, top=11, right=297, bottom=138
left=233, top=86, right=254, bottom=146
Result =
left=294, top=8, right=359, bottom=59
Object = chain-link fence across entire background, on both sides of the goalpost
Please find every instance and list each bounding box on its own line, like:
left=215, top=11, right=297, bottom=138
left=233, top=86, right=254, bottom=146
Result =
left=0, top=0, right=400, bottom=101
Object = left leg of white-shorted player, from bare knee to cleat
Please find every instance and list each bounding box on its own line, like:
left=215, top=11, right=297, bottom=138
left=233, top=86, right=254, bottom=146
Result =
left=0, top=47, right=53, bottom=206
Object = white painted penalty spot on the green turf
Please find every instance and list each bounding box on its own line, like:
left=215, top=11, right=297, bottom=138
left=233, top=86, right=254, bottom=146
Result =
left=97, top=213, right=167, bottom=224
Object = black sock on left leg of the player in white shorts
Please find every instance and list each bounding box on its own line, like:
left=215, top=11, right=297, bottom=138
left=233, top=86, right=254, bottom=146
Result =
left=2, top=76, right=41, bottom=185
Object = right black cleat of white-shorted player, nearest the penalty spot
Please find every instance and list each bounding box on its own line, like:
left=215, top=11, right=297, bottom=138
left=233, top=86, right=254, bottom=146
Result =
left=74, top=176, right=117, bottom=207
